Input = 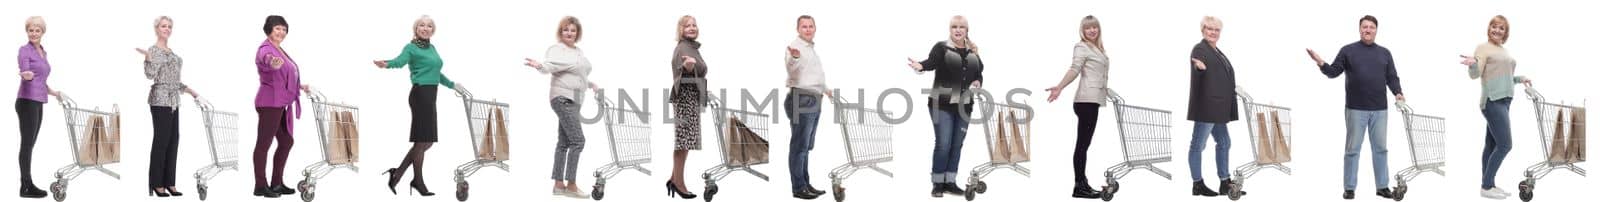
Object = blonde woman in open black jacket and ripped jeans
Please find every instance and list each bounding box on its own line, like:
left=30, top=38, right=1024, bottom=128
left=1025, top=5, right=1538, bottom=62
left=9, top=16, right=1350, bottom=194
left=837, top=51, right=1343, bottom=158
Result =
left=907, top=16, right=984, bottom=197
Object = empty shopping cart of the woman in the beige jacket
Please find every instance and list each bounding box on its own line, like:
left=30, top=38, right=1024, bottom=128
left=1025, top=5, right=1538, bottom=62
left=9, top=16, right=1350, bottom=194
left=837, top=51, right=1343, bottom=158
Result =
left=1101, top=88, right=1173, bottom=202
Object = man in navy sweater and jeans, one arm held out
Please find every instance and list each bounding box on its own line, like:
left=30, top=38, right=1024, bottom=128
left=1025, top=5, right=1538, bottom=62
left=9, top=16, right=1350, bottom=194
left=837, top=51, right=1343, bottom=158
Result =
left=1306, top=16, right=1405, bottom=199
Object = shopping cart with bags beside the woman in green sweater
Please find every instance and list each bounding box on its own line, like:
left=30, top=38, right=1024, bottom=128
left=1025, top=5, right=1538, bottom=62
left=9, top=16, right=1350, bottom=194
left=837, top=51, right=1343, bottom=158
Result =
left=454, top=87, right=510, bottom=202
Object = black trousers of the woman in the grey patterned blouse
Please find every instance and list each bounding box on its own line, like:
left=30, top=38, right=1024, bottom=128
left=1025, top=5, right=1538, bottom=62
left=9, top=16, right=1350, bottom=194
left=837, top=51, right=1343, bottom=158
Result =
left=149, top=106, right=178, bottom=189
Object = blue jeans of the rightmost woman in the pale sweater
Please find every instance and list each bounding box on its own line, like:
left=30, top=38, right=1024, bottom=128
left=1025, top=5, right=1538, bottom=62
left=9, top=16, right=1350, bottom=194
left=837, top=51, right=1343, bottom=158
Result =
left=1482, top=98, right=1510, bottom=189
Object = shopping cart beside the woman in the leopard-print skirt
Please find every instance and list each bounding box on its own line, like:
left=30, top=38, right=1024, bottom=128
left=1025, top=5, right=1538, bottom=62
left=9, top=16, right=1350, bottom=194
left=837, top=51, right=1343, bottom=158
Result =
left=701, top=95, right=771, bottom=202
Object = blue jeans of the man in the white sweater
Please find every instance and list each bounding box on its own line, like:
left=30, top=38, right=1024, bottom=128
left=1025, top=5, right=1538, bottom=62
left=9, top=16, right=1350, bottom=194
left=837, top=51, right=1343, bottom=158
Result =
left=784, top=91, right=822, bottom=192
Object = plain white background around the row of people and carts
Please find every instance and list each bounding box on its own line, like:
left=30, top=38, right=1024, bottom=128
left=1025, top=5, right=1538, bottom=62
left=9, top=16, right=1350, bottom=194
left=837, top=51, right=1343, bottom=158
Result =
left=0, top=0, right=1600, bottom=202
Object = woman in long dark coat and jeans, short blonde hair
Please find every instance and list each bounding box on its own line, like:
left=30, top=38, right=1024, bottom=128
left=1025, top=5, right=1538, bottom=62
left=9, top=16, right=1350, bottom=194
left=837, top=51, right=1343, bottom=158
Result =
left=1189, top=16, right=1238, bottom=197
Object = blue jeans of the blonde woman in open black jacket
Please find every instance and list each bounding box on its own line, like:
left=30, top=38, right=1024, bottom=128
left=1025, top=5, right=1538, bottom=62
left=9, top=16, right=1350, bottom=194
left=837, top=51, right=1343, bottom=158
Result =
left=928, top=107, right=966, bottom=183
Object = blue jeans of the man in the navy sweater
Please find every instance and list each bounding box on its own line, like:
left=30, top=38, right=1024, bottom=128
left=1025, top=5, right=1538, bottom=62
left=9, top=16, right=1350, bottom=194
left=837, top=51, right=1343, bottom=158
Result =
left=1344, top=109, right=1389, bottom=191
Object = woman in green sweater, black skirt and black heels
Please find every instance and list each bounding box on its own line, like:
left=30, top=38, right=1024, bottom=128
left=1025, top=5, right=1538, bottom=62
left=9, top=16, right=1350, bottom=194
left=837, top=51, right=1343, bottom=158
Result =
left=373, top=16, right=461, bottom=196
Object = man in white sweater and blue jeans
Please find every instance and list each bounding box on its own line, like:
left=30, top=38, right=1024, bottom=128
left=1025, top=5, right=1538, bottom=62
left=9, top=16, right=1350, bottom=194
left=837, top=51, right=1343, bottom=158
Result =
left=784, top=16, right=834, bottom=200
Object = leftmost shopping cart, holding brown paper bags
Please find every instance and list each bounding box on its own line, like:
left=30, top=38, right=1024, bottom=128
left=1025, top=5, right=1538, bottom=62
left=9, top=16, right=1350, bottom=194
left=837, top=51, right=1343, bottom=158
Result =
left=50, top=95, right=122, bottom=202
